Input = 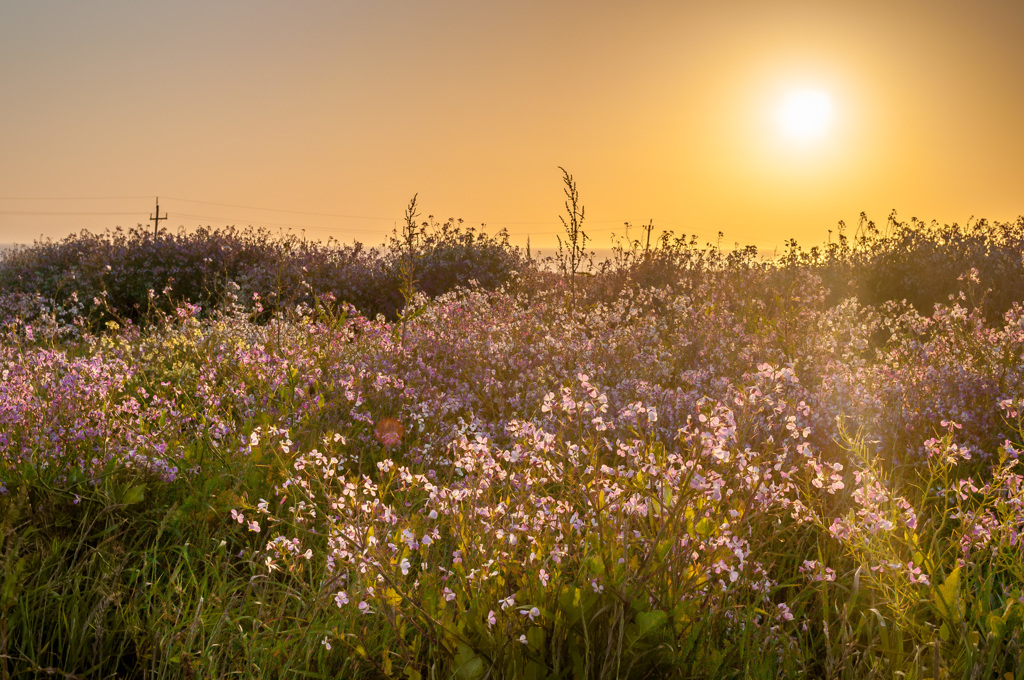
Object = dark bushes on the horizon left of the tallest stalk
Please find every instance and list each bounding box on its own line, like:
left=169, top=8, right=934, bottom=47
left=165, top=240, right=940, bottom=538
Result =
left=0, top=218, right=524, bottom=327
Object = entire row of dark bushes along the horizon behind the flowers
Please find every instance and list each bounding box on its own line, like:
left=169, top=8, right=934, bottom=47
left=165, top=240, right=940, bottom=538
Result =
left=0, top=206, right=1024, bottom=328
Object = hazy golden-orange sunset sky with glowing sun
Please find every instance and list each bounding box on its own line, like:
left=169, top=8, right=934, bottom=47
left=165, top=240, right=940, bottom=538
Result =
left=0, top=0, right=1024, bottom=254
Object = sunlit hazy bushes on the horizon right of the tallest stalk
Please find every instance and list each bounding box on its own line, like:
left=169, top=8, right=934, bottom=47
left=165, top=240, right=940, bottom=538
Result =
left=587, top=213, right=1024, bottom=323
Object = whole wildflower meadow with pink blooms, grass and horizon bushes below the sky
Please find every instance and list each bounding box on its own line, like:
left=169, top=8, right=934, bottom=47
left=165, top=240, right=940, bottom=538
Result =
left=0, top=202, right=1024, bottom=680
